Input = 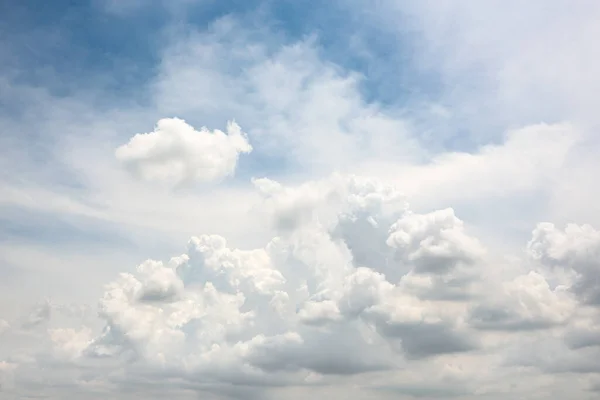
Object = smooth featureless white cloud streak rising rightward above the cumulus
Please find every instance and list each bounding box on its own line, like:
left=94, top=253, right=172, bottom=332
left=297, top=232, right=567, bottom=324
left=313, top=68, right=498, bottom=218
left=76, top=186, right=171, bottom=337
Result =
left=358, top=123, right=582, bottom=206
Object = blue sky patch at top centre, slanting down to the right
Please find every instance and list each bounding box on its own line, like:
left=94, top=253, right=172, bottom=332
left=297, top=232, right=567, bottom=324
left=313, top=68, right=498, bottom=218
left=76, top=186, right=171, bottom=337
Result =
left=169, top=0, right=441, bottom=106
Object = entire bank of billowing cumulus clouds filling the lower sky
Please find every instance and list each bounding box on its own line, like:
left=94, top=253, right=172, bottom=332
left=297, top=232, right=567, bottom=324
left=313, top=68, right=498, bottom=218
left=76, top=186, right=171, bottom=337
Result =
left=5, top=175, right=600, bottom=398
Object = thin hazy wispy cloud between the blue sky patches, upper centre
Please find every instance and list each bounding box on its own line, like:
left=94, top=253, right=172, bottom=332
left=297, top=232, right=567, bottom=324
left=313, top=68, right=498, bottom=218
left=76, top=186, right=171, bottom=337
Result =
left=152, top=22, right=423, bottom=175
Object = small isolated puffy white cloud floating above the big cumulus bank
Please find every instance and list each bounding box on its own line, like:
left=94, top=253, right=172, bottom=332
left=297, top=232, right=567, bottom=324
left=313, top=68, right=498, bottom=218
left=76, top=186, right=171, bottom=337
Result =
left=115, top=118, right=252, bottom=185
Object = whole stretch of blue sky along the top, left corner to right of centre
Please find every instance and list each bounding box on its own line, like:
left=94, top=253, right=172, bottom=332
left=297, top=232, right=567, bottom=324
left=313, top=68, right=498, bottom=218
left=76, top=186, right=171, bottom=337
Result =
left=2, top=0, right=446, bottom=111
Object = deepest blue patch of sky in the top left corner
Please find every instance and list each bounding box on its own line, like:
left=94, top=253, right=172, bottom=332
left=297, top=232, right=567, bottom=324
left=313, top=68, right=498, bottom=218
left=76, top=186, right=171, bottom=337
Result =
left=0, top=0, right=166, bottom=101
